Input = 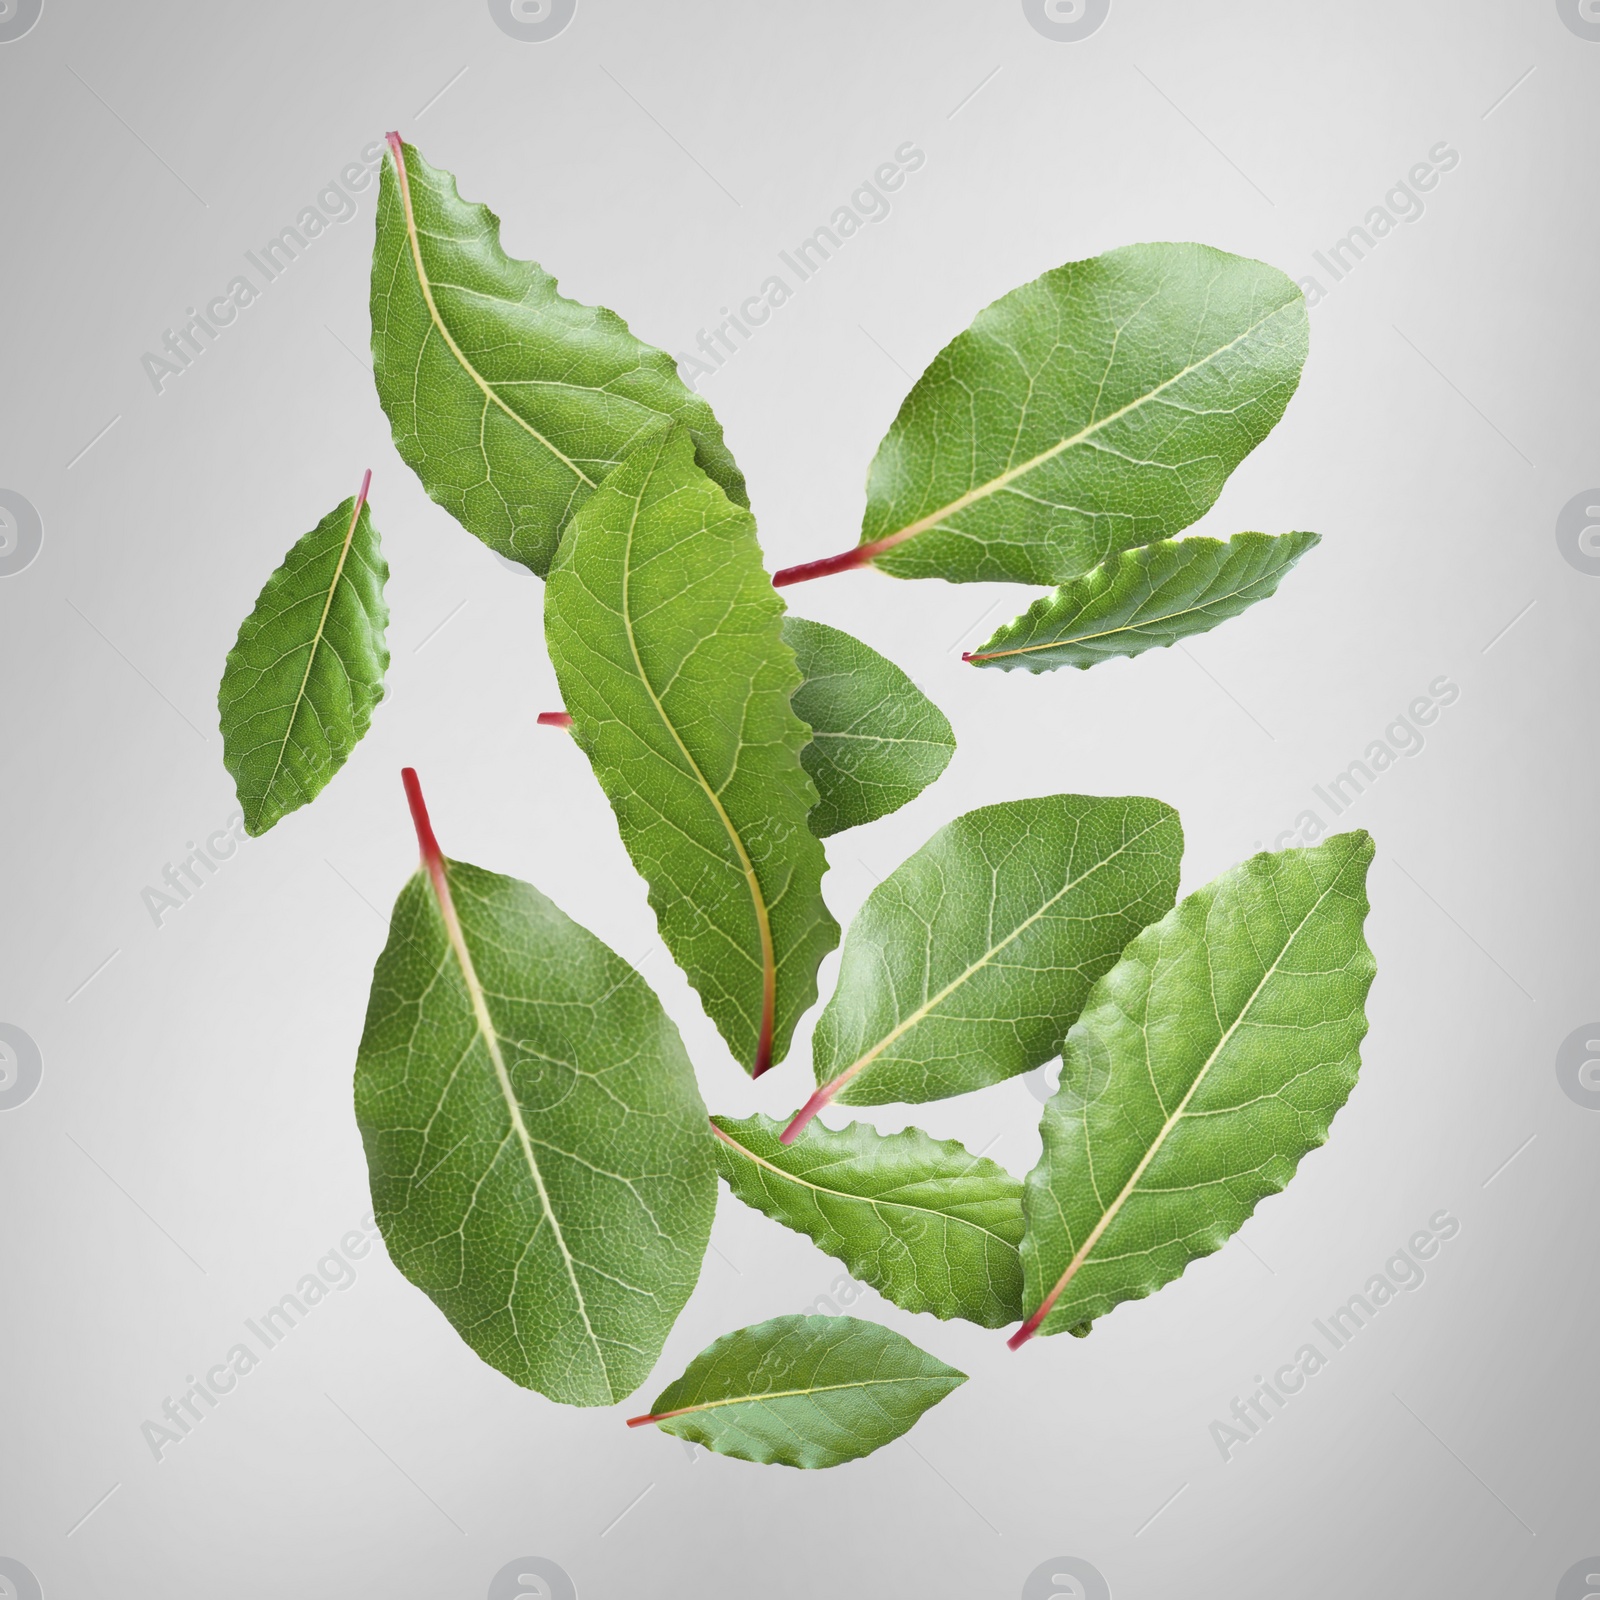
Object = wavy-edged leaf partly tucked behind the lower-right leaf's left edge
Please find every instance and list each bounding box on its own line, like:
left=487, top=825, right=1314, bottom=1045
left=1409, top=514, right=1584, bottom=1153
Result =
left=712, top=1115, right=1022, bottom=1328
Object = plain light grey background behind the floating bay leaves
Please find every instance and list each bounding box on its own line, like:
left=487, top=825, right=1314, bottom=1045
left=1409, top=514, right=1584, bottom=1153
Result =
left=0, top=0, right=1600, bottom=1600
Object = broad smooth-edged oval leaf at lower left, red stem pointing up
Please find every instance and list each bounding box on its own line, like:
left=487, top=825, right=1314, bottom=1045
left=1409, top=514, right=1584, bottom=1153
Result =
left=355, top=771, right=717, bottom=1405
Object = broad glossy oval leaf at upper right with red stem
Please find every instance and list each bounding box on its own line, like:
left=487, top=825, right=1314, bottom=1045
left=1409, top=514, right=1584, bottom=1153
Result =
left=778, top=245, right=1307, bottom=598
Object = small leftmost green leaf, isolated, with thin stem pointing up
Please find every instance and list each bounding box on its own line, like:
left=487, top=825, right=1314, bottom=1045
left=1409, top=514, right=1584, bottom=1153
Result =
left=218, top=472, right=389, bottom=834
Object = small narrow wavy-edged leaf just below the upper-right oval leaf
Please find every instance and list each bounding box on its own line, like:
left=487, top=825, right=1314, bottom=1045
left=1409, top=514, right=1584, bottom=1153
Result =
left=962, top=533, right=1320, bottom=672
